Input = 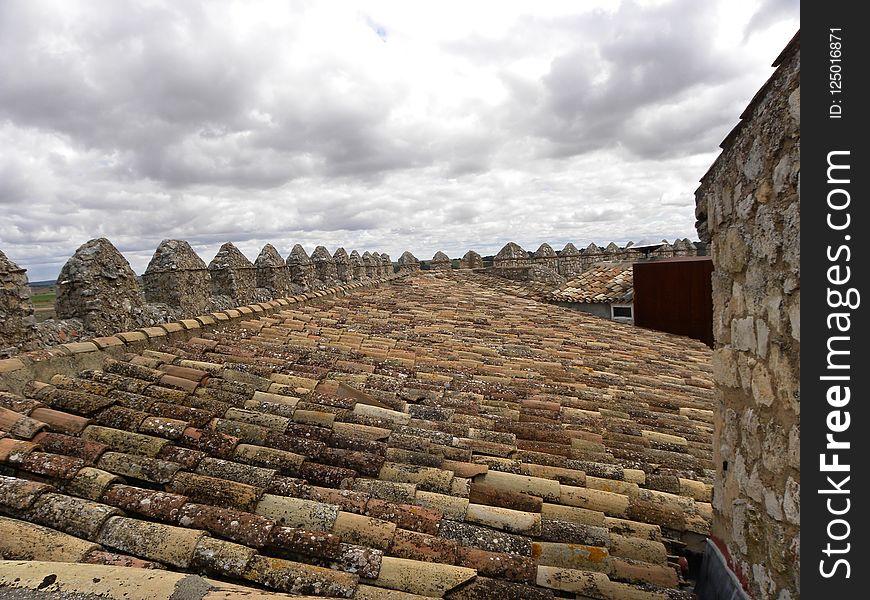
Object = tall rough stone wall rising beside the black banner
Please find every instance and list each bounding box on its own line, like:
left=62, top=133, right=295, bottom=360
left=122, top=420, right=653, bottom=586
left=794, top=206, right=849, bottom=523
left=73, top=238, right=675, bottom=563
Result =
left=695, top=36, right=800, bottom=600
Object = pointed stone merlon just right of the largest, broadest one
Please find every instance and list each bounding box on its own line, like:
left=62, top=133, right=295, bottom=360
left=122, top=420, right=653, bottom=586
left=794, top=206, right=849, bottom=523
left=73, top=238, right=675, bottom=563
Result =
left=142, top=240, right=211, bottom=316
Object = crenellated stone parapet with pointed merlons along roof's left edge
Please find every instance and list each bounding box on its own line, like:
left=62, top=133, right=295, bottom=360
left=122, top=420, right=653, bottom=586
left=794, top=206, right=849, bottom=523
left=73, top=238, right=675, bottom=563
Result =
left=0, top=238, right=406, bottom=358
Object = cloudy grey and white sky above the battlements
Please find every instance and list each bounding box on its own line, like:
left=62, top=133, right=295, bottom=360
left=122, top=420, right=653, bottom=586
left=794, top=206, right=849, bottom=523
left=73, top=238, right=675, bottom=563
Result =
left=0, top=0, right=799, bottom=281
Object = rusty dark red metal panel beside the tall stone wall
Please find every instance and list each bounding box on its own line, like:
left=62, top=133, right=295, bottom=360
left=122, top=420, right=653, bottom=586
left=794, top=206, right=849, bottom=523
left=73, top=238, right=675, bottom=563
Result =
left=634, top=256, right=713, bottom=348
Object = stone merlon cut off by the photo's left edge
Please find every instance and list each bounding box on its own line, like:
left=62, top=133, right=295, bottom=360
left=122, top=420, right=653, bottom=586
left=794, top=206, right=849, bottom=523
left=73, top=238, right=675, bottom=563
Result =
left=0, top=252, right=36, bottom=358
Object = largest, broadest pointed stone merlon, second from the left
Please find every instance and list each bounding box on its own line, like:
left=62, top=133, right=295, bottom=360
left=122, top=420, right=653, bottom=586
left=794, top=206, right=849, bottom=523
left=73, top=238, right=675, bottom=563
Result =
left=55, top=238, right=145, bottom=335
